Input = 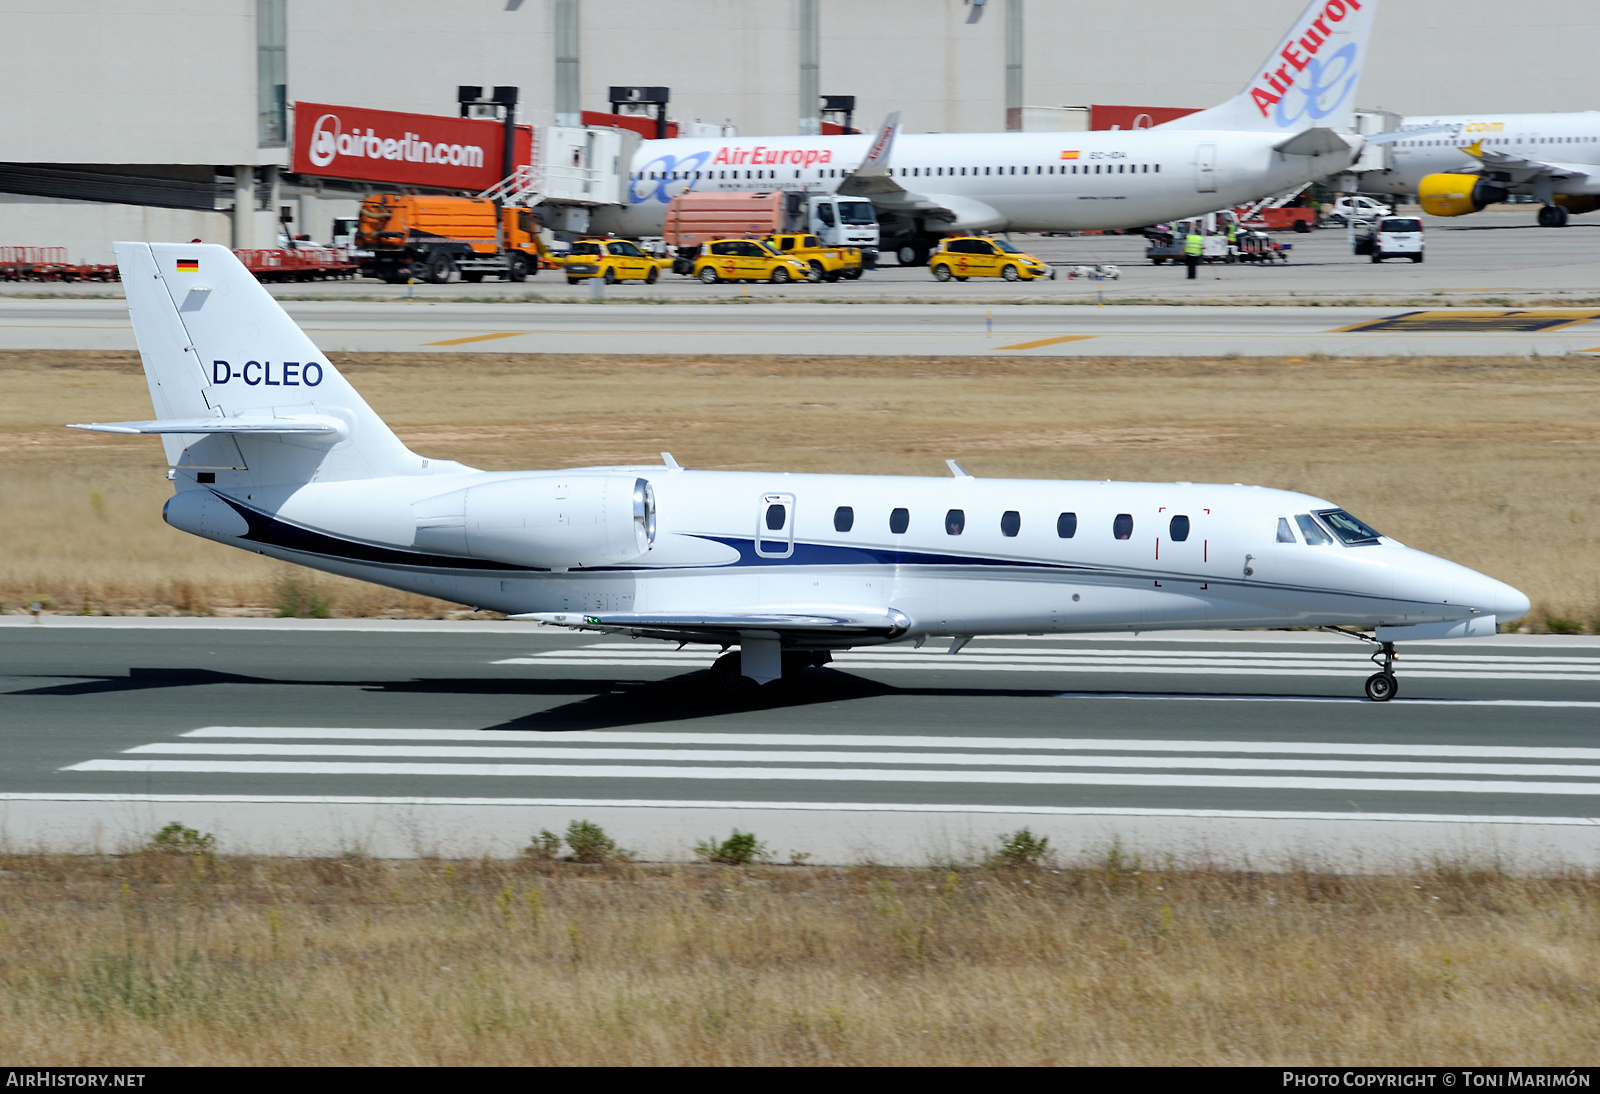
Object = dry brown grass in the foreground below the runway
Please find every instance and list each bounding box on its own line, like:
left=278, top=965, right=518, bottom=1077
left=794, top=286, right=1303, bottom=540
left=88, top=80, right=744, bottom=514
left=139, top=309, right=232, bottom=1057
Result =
left=0, top=852, right=1600, bottom=1067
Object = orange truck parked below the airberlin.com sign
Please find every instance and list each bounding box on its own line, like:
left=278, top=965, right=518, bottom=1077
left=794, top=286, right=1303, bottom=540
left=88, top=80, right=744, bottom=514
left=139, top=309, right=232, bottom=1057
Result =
left=355, top=194, right=544, bottom=285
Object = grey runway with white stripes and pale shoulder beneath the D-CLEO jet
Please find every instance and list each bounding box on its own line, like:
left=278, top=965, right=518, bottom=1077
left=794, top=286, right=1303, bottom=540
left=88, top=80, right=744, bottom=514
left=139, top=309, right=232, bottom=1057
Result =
left=0, top=617, right=1600, bottom=862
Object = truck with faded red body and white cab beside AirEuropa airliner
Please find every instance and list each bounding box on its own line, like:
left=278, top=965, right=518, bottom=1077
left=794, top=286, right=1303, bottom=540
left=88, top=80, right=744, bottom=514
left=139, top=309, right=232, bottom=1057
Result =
left=662, top=190, right=878, bottom=269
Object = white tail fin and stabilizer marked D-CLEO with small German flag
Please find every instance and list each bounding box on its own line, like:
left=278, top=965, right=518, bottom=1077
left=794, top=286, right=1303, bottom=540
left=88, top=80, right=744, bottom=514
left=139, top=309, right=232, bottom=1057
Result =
left=75, top=243, right=430, bottom=493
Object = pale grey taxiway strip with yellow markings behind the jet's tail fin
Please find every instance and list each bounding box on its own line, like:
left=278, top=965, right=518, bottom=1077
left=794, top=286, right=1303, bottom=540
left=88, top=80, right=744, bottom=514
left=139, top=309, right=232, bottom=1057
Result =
left=0, top=299, right=1600, bottom=357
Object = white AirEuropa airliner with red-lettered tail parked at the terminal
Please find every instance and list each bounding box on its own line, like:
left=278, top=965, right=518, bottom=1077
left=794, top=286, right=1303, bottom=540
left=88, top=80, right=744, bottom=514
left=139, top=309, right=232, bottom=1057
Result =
left=592, top=0, right=1389, bottom=266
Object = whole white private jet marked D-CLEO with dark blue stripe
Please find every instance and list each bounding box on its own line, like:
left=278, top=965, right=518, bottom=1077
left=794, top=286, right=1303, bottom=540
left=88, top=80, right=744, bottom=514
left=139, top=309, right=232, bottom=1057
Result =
left=75, top=243, right=1528, bottom=701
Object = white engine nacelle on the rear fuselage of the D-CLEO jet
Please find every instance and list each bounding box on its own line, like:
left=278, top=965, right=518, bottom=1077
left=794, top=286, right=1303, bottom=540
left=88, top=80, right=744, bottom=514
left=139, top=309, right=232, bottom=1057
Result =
left=413, top=473, right=656, bottom=569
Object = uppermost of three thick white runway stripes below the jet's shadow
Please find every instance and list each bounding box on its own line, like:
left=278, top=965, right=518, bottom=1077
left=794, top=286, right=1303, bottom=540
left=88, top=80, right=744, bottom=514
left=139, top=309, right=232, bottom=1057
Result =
left=182, top=726, right=1600, bottom=761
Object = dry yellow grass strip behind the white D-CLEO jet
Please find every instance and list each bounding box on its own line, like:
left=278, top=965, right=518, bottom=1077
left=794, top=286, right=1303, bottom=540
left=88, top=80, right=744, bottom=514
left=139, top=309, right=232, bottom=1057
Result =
left=0, top=352, right=1600, bottom=627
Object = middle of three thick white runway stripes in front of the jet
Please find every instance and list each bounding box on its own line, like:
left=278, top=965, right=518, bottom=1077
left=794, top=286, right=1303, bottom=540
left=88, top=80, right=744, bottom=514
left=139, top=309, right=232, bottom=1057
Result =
left=123, top=742, right=1600, bottom=777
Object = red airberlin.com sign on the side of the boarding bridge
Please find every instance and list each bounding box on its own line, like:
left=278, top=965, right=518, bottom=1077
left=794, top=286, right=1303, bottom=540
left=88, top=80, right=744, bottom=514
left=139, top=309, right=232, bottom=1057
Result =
left=293, top=102, right=533, bottom=190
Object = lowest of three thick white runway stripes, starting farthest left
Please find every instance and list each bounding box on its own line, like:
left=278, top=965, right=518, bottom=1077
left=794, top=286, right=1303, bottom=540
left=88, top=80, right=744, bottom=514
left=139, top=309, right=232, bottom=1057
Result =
left=64, top=760, right=1600, bottom=797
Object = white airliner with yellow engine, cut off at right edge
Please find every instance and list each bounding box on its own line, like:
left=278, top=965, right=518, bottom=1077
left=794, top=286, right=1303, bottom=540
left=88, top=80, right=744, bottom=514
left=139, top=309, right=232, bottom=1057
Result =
left=1362, top=110, right=1600, bottom=227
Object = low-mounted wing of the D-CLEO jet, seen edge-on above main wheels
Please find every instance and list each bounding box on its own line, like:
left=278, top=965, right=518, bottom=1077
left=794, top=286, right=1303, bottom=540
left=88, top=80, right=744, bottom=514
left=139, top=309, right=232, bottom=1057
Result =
left=512, top=608, right=910, bottom=645
